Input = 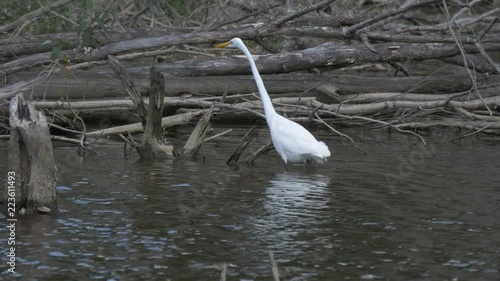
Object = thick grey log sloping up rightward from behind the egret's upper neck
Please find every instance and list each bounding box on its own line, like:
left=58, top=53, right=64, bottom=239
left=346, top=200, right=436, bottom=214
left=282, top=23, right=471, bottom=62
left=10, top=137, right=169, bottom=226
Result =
left=117, top=41, right=500, bottom=77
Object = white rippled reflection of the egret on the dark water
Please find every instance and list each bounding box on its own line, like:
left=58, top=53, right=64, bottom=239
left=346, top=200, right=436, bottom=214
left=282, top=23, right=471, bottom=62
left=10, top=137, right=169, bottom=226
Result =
left=250, top=173, right=331, bottom=249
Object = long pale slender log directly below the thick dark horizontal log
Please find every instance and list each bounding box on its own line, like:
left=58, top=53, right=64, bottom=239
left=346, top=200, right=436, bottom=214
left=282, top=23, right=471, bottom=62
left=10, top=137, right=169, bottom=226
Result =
left=25, top=92, right=500, bottom=120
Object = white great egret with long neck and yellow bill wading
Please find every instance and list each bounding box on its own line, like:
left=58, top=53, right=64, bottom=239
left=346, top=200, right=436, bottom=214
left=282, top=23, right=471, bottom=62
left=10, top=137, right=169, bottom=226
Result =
left=215, top=38, right=330, bottom=167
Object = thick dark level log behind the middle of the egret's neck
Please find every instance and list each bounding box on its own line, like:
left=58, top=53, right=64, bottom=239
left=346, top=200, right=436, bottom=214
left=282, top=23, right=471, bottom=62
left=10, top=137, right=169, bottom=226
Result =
left=4, top=71, right=500, bottom=101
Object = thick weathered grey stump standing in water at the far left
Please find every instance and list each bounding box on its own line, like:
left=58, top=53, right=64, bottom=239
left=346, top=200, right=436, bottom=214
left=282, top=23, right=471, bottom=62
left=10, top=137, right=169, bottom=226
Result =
left=2, top=94, right=57, bottom=214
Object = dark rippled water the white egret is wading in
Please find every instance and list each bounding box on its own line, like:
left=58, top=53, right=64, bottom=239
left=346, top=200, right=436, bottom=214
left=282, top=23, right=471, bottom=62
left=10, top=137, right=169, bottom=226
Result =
left=0, top=127, right=500, bottom=280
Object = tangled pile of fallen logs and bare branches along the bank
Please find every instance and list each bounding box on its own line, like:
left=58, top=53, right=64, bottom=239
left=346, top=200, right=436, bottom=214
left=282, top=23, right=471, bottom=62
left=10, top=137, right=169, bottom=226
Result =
left=0, top=0, right=500, bottom=137
